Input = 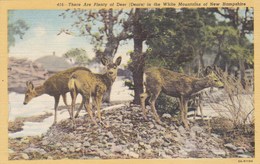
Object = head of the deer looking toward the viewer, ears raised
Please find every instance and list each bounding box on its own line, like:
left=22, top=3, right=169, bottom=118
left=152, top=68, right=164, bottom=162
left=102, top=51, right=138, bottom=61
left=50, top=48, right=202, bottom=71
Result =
left=101, top=56, right=122, bottom=80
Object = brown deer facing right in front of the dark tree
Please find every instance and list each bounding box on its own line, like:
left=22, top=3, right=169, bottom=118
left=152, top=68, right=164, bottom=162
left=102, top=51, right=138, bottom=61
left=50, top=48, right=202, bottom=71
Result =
left=140, top=67, right=224, bottom=129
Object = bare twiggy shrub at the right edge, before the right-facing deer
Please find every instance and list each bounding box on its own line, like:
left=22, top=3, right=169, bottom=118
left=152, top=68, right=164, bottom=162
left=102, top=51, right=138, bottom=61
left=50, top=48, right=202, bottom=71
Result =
left=206, top=73, right=254, bottom=131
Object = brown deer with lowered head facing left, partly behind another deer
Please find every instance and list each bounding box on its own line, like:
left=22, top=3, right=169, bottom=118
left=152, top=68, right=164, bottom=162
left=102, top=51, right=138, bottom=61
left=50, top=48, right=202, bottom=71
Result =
left=23, top=67, right=90, bottom=124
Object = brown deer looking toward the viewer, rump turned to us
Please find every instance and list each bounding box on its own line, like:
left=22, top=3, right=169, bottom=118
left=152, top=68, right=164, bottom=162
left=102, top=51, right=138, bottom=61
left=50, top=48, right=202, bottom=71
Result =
left=68, top=57, right=122, bottom=124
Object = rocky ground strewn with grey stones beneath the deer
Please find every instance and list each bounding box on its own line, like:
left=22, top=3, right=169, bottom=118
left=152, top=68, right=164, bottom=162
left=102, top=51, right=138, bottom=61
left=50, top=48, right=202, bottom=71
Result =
left=9, top=106, right=254, bottom=160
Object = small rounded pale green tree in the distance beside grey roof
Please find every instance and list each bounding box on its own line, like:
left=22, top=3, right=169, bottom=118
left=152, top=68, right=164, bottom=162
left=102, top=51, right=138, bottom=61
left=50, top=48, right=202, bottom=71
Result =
left=63, top=48, right=90, bottom=65
